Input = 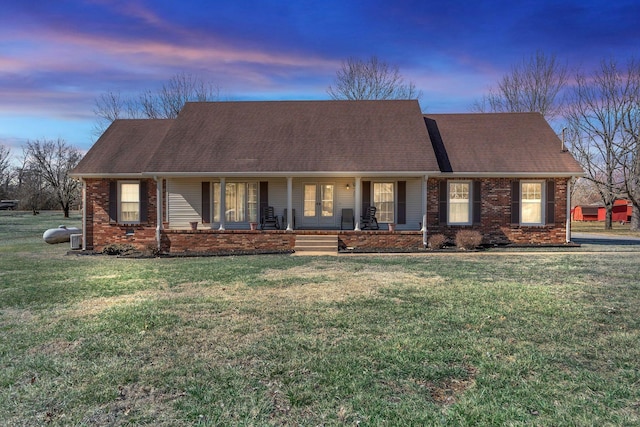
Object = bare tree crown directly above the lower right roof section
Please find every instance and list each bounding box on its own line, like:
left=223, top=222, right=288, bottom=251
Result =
left=472, top=51, right=568, bottom=120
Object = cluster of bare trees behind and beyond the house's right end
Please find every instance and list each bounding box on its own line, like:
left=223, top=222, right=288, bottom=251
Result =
left=473, top=52, right=640, bottom=231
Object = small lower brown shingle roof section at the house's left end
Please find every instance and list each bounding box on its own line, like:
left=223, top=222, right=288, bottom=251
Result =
left=73, top=119, right=173, bottom=176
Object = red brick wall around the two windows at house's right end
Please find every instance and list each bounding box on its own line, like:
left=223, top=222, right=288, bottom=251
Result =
left=427, top=178, right=568, bottom=244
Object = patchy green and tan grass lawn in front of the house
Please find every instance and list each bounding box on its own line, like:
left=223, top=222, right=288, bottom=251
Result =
left=0, top=212, right=640, bottom=426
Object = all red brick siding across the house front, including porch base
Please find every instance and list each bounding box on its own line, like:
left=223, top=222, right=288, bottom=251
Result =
left=85, top=178, right=567, bottom=253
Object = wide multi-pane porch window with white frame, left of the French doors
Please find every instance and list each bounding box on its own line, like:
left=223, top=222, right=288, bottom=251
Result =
left=212, top=182, right=258, bottom=222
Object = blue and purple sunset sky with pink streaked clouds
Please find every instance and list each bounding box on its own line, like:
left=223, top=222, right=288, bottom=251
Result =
left=0, top=0, right=640, bottom=155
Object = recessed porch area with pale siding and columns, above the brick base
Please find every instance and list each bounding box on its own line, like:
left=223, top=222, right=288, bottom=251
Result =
left=155, top=175, right=426, bottom=231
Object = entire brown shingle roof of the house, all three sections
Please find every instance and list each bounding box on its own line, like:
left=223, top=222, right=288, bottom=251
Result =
left=73, top=101, right=583, bottom=176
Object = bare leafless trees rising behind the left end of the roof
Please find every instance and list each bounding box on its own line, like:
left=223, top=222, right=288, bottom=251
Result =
left=93, top=73, right=220, bottom=136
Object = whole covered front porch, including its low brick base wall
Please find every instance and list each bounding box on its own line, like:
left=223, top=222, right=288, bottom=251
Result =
left=156, top=175, right=426, bottom=254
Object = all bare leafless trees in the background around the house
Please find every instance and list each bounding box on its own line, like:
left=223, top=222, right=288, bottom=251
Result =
left=0, top=56, right=640, bottom=230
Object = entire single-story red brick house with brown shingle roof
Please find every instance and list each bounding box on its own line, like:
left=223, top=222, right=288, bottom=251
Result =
left=72, top=100, right=583, bottom=253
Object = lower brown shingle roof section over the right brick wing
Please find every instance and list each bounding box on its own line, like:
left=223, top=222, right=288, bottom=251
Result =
left=424, top=113, right=583, bottom=175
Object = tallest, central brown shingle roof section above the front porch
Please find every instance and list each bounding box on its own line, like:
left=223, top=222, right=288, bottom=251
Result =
left=147, top=101, right=438, bottom=173
